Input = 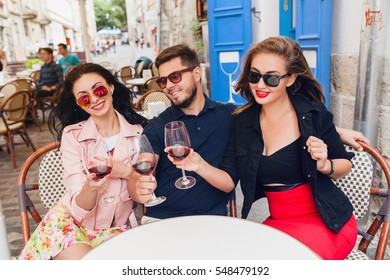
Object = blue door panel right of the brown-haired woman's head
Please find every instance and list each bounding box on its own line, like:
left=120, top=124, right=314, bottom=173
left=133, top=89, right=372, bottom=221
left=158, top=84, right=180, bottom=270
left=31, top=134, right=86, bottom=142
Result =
left=295, top=0, right=332, bottom=106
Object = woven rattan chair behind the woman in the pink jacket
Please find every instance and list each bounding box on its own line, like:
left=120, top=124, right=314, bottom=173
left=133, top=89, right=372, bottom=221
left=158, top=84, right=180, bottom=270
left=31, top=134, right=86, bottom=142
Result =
left=17, top=142, right=65, bottom=245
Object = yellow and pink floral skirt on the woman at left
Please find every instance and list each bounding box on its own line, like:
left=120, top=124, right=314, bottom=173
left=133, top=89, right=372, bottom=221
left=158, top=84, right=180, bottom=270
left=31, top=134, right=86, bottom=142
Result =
left=19, top=204, right=130, bottom=260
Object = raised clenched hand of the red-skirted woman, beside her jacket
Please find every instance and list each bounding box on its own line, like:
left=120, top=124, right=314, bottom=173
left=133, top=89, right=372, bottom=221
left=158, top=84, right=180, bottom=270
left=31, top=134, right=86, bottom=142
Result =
left=306, top=136, right=330, bottom=174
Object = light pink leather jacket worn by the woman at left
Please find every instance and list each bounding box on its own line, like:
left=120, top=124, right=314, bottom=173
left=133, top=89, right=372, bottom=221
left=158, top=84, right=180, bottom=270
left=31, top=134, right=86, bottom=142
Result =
left=60, top=112, right=143, bottom=229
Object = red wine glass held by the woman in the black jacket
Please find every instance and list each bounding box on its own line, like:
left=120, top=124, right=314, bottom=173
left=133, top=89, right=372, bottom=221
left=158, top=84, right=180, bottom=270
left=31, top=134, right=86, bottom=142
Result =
left=164, top=121, right=196, bottom=190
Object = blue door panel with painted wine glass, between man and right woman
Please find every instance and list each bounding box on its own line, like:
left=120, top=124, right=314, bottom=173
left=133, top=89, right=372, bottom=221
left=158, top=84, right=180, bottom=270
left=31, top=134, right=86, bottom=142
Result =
left=207, top=0, right=252, bottom=105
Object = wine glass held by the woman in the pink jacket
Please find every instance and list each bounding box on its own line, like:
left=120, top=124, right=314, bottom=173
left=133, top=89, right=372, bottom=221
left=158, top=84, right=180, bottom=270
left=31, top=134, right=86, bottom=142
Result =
left=84, top=139, right=115, bottom=204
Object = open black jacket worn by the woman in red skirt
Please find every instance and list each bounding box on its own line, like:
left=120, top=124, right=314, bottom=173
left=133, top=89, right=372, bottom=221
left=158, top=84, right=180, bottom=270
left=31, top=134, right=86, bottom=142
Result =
left=221, top=94, right=354, bottom=233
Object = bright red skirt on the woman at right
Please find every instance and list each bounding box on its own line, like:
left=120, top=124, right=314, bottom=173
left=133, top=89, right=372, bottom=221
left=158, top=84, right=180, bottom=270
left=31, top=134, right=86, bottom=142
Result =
left=263, top=184, right=357, bottom=260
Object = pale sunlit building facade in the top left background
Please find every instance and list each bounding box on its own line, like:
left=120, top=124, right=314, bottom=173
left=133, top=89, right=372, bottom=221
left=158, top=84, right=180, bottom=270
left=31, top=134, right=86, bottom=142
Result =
left=0, top=0, right=96, bottom=63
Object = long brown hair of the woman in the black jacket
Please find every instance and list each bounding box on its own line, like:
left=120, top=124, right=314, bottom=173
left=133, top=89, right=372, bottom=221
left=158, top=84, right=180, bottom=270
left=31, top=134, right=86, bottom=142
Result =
left=235, top=36, right=325, bottom=112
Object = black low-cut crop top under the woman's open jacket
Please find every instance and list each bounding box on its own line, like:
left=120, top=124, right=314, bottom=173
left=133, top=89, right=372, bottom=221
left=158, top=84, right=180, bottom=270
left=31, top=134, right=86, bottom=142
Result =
left=257, top=138, right=307, bottom=186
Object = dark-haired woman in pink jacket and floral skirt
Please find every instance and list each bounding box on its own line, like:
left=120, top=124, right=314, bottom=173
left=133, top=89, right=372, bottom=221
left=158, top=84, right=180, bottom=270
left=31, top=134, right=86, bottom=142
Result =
left=19, top=63, right=149, bottom=259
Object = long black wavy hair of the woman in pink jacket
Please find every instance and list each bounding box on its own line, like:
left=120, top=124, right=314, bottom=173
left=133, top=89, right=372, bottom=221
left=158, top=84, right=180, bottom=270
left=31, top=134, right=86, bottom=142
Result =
left=48, top=63, right=147, bottom=141
